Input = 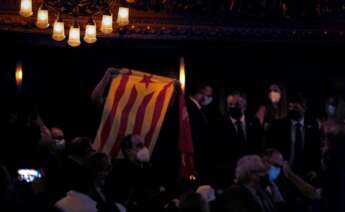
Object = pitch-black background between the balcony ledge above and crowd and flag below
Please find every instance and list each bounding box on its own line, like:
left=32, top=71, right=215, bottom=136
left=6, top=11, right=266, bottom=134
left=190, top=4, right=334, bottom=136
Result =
left=0, top=32, right=345, bottom=138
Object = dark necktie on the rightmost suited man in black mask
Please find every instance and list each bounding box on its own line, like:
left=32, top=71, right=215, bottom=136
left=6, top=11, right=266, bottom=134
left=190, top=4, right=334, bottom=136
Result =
left=293, top=123, right=303, bottom=173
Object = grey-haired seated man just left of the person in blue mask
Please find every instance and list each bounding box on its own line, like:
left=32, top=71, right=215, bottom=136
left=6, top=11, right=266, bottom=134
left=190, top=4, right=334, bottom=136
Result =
left=221, top=155, right=277, bottom=212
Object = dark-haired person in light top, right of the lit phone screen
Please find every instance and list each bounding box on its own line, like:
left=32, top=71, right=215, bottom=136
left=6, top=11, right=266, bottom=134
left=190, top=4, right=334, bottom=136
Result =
left=55, top=167, right=98, bottom=212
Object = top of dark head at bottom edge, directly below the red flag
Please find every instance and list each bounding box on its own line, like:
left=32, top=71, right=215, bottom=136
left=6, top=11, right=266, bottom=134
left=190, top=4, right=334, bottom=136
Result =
left=179, top=192, right=210, bottom=212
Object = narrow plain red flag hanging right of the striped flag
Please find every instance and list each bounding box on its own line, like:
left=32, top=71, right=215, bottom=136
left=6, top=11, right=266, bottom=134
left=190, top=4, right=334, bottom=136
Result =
left=178, top=85, right=196, bottom=179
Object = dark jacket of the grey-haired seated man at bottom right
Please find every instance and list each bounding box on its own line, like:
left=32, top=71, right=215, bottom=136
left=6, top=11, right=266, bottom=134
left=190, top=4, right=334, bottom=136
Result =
left=221, top=185, right=275, bottom=212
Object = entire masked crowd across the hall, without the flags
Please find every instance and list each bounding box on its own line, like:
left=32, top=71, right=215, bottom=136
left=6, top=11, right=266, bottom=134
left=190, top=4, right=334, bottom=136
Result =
left=0, top=68, right=345, bottom=212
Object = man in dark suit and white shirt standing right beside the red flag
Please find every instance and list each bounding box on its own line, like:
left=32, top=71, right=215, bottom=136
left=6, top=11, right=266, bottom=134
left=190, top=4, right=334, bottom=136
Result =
left=186, top=84, right=213, bottom=180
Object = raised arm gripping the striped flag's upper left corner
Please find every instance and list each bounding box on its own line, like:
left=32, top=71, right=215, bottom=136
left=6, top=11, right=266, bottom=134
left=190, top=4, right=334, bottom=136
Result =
left=91, top=67, right=121, bottom=105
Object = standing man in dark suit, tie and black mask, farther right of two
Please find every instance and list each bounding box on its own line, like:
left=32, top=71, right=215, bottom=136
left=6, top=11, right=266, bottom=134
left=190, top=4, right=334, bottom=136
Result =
left=267, top=95, right=321, bottom=212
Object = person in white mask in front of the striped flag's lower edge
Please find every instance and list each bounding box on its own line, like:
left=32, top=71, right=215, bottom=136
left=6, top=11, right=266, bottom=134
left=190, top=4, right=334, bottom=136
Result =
left=108, top=135, right=160, bottom=211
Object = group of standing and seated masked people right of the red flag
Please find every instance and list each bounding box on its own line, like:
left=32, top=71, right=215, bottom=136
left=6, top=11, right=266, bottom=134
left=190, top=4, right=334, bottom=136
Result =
left=187, top=80, right=345, bottom=211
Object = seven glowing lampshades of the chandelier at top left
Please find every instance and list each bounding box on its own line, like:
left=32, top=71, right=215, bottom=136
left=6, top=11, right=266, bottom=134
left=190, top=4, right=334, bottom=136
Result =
left=19, top=0, right=129, bottom=47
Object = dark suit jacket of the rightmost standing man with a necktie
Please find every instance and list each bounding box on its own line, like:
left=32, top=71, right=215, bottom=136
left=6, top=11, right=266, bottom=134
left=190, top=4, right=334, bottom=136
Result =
left=266, top=118, right=321, bottom=174
